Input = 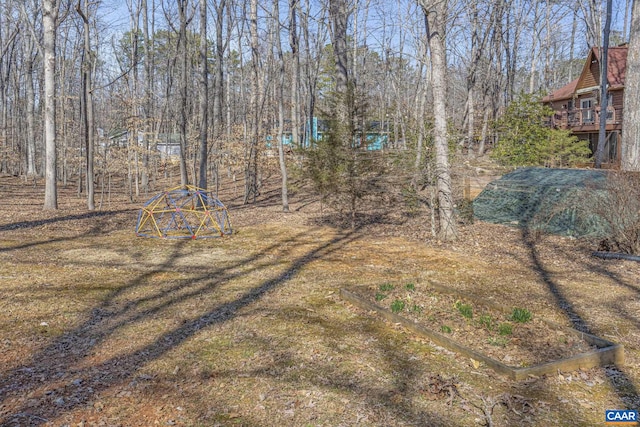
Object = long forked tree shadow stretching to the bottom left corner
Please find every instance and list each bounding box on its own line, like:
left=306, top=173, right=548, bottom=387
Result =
left=0, top=222, right=444, bottom=426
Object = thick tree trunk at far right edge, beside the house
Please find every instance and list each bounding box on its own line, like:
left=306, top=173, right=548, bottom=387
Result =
left=621, top=1, right=640, bottom=172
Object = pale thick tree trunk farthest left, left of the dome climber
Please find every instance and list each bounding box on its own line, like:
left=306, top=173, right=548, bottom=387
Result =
left=42, top=0, right=60, bottom=210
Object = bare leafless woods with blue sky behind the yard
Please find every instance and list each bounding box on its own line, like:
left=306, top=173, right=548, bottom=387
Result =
left=0, top=0, right=638, bottom=239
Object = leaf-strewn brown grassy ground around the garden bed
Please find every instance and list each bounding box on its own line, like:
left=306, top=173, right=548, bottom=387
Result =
left=0, top=168, right=640, bottom=426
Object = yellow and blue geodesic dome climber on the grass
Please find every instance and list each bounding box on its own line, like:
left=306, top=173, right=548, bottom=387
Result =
left=136, top=185, right=233, bottom=239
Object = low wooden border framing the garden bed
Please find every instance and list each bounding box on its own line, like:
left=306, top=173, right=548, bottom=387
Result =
left=340, top=282, right=624, bottom=380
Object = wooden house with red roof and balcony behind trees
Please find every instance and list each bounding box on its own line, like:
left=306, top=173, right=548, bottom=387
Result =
left=542, top=45, right=627, bottom=168
